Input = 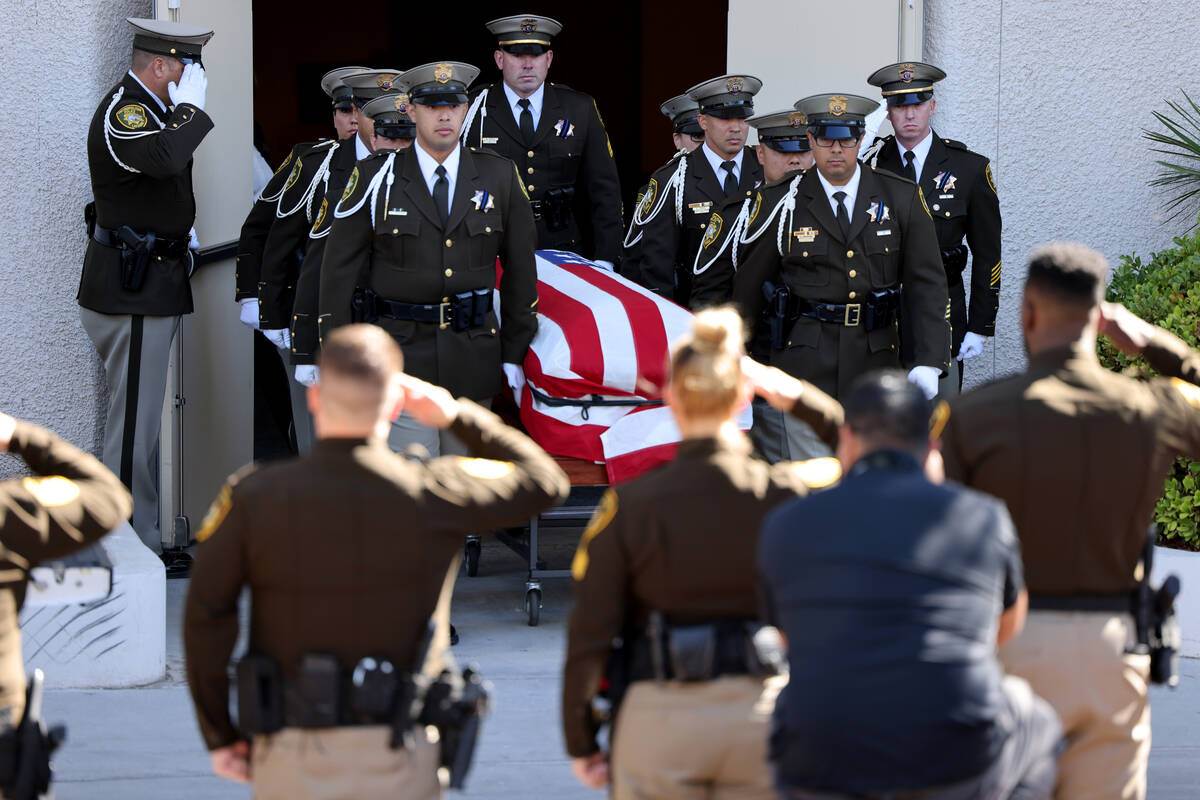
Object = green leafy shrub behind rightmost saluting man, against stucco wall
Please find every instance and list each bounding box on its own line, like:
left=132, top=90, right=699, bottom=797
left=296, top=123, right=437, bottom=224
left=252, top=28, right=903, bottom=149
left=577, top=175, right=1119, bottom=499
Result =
left=1100, top=231, right=1200, bottom=548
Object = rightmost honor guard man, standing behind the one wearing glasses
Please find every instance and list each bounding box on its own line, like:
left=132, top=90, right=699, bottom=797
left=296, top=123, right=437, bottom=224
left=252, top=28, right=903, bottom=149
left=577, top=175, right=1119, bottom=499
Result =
left=864, top=61, right=1001, bottom=389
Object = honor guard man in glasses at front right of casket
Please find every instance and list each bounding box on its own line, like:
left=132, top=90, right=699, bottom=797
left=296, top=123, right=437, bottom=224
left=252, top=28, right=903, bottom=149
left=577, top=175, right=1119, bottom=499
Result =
left=733, top=95, right=949, bottom=459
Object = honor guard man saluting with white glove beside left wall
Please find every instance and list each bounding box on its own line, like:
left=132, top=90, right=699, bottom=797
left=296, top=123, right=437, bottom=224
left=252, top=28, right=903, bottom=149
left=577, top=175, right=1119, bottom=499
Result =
left=78, top=19, right=212, bottom=553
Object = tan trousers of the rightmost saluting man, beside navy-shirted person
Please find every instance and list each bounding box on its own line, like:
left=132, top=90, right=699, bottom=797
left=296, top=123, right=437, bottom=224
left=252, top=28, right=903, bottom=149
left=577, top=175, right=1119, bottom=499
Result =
left=1000, top=610, right=1150, bottom=800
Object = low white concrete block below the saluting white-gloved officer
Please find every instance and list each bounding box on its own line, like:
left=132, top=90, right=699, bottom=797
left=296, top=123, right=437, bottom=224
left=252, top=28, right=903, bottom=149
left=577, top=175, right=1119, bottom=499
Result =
left=20, top=523, right=167, bottom=688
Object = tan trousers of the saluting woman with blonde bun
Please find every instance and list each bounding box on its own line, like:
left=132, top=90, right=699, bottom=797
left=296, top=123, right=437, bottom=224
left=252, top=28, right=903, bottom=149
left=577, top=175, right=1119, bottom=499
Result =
left=612, top=676, right=787, bottom=800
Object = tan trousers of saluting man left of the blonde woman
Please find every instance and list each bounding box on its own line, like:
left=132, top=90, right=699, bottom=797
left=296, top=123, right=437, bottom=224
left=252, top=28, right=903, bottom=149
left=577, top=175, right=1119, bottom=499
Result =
left=250, top=726, right=443, bottom=800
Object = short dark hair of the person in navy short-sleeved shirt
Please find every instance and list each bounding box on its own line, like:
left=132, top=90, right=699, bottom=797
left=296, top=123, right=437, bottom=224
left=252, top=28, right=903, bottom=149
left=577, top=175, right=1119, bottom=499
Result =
left=844, top=369, right=934, bottom=450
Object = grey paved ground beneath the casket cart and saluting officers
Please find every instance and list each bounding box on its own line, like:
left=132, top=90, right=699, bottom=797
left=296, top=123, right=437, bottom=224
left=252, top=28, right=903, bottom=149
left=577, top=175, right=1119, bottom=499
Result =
left=39, top=531, right=1200, bottom=800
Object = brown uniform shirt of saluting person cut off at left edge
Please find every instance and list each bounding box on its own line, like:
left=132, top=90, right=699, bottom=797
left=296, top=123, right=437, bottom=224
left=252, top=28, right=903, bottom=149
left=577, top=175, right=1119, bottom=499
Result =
left=0, top=422, right=133, bottom=723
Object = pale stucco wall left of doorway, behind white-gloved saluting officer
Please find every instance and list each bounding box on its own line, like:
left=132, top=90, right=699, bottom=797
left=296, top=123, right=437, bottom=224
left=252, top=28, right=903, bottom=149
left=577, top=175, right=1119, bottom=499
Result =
left=0, top=0, right=150, bottom=475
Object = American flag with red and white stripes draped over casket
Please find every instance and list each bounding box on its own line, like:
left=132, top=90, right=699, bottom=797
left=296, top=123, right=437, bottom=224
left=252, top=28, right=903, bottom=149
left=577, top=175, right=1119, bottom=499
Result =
left=514, top=249, right=750, bottom=483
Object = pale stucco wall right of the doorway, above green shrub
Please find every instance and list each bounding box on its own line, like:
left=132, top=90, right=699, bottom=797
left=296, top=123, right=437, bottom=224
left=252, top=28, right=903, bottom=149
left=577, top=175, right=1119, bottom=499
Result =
left=925, top=0, right=1200, bottom=384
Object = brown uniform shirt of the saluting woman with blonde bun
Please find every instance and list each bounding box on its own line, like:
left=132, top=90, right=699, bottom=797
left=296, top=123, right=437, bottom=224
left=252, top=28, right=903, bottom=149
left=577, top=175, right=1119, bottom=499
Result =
left=563, top=387, right=841, bottom=758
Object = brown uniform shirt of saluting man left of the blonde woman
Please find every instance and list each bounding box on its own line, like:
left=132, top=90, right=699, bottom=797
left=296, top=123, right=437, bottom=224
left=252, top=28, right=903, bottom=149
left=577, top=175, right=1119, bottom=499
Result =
left=184, top=401, right=570, bottom=748
